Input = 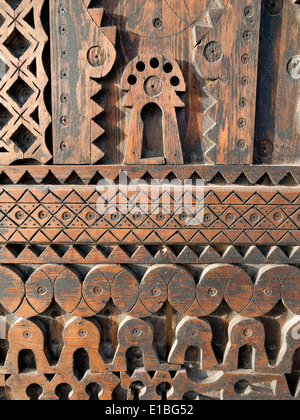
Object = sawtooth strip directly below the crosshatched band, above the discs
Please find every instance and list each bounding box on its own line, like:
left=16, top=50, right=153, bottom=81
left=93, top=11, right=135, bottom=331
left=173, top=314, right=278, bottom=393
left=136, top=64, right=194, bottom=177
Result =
left=0, top=243, right=300, bottom=264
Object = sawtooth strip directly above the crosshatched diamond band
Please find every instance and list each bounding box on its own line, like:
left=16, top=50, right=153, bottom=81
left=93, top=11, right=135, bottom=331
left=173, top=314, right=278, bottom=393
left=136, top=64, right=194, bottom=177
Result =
left=0, top=165, right=300, bottom=186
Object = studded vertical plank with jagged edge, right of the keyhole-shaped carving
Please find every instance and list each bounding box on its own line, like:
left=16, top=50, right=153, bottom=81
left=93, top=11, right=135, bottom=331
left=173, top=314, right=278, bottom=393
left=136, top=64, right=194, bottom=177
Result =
left=194, top=0, right=261, bottom=165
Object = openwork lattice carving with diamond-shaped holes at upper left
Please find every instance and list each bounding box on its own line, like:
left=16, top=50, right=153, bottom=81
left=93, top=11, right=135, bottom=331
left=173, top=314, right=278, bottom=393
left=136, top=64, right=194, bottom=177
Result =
left=0, top=0, right=51, bottom=164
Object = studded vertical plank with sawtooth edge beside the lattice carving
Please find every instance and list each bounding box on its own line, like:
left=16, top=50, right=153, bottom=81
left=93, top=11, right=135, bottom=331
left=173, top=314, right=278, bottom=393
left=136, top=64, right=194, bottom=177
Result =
left=50, top=0, right=116, bottom=165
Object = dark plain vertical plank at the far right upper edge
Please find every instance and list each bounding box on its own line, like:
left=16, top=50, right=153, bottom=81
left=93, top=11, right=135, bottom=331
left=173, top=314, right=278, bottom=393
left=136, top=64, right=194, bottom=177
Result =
left=255, top=0, right=300, bottom=165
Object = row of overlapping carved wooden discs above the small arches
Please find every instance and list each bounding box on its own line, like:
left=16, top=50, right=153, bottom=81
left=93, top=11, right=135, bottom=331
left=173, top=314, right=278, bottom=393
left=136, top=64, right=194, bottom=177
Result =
left=0, top=264, right=300, bottom=318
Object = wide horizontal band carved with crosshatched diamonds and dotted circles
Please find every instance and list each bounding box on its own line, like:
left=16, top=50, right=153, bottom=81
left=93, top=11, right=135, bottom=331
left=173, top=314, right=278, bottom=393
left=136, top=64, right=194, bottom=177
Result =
left=0, top=186, right=300, bottom=246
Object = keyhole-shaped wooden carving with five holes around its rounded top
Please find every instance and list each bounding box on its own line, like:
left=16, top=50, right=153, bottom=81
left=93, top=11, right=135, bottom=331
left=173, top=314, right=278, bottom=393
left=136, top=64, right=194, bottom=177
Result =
left=122, top=53, right=186, bottom=165
